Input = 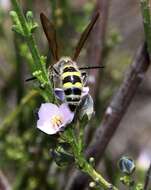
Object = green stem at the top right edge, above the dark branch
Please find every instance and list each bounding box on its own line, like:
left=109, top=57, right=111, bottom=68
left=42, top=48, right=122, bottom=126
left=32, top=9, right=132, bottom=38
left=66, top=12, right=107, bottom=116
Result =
left=140, top=0, right=151, bottom=58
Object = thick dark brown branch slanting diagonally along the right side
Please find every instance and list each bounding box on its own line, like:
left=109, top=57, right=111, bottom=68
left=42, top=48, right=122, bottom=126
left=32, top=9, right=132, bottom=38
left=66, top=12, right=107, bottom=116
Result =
left=66, top=44, right=150, bottom=190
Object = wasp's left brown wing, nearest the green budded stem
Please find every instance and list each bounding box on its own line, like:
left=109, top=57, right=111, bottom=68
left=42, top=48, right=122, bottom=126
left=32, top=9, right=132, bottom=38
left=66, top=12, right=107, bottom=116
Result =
left=40, top=13, right=59, bottom=61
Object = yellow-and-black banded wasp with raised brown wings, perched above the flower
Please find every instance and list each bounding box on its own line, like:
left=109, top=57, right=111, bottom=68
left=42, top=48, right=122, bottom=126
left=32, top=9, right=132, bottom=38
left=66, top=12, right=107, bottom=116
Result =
left=40, top=13, right=102, bottom=112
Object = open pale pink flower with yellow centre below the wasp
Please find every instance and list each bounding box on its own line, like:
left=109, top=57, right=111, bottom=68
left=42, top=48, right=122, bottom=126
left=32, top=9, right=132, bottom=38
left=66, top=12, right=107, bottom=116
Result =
left=37, top=103, right=74, bottom=135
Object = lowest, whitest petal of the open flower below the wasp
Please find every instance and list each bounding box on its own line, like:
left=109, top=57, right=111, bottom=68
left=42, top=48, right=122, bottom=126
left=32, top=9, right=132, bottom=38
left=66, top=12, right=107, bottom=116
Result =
left=37, top=120, right=60, bottom=135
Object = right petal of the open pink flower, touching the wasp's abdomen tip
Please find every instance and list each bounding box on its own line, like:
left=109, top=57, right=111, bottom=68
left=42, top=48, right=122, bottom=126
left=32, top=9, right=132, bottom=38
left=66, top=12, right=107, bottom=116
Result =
left=59, top=103, right=74, bottom=125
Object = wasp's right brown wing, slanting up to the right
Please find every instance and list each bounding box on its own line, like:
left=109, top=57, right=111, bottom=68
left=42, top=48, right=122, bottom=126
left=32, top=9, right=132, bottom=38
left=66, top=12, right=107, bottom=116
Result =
left=73, top=12, right=100, bottom=60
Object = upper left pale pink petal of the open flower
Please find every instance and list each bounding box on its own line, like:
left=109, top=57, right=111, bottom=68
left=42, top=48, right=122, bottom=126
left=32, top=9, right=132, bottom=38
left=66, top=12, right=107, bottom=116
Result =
left=38, top=103, right=58, bottom=120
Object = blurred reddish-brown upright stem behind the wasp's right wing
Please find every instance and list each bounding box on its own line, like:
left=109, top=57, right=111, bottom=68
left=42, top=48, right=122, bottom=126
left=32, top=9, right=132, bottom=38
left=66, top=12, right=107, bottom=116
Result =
left=87, top=0, right=110, bottom=98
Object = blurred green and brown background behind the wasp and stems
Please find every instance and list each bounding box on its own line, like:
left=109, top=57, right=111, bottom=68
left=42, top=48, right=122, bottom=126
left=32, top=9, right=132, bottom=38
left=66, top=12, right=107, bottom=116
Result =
left=0, top=0, right=151, bottom=190
